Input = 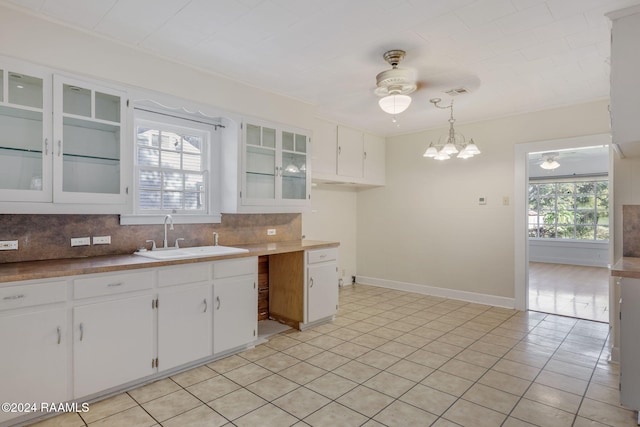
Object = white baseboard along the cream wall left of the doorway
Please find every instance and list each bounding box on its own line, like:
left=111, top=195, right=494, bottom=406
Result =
left=357, top=276, right=515, bottom=308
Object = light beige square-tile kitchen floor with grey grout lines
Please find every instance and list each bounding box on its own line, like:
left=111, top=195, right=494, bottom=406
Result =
left=27, top=285, right=637, bottom=427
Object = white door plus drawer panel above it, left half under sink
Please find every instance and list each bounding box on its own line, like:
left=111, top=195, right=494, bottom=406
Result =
left=157, top=263, right=213, bottom=371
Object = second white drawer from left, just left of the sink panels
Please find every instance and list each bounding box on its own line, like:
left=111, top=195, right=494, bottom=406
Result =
left=73, top=270, right=153, bottom=299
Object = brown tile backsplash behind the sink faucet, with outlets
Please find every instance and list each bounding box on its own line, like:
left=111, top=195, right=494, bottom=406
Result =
left=0, top=214, right=302, bottom=263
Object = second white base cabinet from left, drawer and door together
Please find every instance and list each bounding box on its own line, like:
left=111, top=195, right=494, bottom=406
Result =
left=73, top=269, right=156, bottom=398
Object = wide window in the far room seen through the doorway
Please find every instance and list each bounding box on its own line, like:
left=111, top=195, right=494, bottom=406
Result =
left=529, top=178, right=609, bottom=241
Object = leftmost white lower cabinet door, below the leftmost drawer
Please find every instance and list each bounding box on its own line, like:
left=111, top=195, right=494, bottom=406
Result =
left=0, top=308, right=69, bottom=423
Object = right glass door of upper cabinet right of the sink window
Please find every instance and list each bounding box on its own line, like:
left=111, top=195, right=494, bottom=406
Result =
left=280, top=131, right=307, bottom=200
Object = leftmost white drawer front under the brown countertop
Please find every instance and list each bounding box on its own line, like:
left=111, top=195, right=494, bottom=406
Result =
left=0, top=281, right=67, bottom=310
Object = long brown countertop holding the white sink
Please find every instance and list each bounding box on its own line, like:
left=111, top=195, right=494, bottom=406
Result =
left=0, top=240, right=340, bottom=283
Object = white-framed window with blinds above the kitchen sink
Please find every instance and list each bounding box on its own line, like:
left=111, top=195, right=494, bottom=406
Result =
left=129, top=110, right=221, bottom=222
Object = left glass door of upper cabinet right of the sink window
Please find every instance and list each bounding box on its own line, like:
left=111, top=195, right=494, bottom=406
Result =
left=244, top=123, right=277, bottom=200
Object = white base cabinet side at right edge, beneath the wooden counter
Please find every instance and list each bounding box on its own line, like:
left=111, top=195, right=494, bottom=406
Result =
left=620, top=277, right=640, bottom=410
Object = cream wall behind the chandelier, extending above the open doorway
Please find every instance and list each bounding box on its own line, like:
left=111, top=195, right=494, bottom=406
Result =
left=357, top=101, right=609, bottom=306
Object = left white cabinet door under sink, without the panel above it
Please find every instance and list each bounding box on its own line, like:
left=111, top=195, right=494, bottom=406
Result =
left=158, top=283, right=213, bottom=371
